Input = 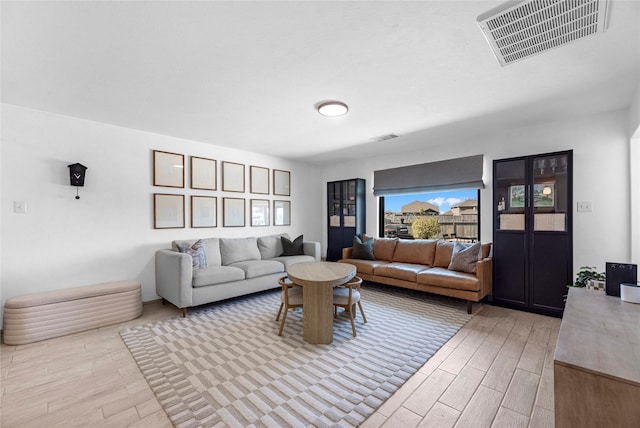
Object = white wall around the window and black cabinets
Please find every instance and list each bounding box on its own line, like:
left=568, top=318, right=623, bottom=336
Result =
left=323, top=110, right=630, bottom=271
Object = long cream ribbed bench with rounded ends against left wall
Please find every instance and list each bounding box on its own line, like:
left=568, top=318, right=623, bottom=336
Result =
left=3, top=281, right=142, bottom=345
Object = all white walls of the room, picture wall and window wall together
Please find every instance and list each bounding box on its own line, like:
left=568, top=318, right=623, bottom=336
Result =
left=0, top=105, right=640, bottom=332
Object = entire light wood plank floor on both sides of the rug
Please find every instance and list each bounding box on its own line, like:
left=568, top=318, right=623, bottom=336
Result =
left=0, top=301, right=560, bottom=428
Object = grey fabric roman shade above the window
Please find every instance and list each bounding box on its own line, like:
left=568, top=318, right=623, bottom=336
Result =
left=373, top=155, right=484, bottom=196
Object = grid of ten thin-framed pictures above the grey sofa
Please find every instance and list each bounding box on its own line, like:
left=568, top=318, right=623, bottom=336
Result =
left=152, top=150, right=291, bottom=229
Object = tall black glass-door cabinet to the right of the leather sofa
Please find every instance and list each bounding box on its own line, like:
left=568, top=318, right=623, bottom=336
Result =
left=491, top=151, right=573, bottom=316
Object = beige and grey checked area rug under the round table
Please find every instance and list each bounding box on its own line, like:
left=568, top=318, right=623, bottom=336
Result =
left=120, top=284, right=471, bottom=428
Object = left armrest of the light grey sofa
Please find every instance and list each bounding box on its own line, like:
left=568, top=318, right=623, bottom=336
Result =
left=156, top=250, right=193, bottom=308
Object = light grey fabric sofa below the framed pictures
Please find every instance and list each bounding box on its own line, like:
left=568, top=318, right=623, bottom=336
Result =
left=156, top=234, right=320, bottom=316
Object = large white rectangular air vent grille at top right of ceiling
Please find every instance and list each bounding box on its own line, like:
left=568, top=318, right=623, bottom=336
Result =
left=478, top=0, right=608, bottom=66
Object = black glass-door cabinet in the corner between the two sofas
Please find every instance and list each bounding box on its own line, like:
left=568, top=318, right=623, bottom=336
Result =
left=327, top=178, right=366, bottom=262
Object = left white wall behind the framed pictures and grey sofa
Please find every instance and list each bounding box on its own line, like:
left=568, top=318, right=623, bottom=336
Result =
left=1, top=105, right=324, bottom=326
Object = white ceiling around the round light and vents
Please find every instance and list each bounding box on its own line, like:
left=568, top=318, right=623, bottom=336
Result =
left=1, top=0, right=640, bottom=164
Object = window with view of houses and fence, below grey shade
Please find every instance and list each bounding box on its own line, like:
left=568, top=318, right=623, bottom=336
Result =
left=379, top=189, right=480, bottom=242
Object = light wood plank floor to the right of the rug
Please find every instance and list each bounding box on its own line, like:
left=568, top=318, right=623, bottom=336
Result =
left=363, top=304, right=561, bottom=428
